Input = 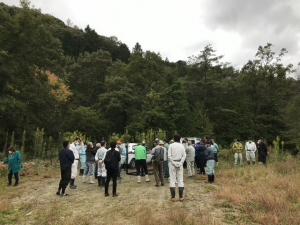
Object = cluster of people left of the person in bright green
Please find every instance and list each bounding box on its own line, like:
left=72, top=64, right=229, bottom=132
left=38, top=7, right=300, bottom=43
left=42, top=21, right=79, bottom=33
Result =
left=56, top=138, right=121, bottom=197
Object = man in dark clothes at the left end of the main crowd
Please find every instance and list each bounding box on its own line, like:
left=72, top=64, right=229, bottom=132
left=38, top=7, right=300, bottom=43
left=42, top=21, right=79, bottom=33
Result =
left=56, top=141, right=75, bottom=196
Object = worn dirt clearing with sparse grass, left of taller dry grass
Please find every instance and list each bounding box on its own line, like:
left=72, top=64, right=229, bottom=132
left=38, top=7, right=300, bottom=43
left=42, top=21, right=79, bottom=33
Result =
left=0, top=170, right=237, bottom=225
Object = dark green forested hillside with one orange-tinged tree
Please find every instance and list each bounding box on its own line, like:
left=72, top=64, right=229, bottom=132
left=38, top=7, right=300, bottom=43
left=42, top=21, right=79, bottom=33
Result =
left=0, top=1, right=300, bottom=154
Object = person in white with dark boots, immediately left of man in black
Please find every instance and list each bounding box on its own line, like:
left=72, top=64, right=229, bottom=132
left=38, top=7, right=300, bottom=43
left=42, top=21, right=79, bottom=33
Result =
left=95, top=141, right=107, bottom=187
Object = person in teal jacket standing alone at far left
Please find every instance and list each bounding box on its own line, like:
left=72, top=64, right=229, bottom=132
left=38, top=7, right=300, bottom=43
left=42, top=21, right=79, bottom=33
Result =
left=5, top=147, right=22, bottom=186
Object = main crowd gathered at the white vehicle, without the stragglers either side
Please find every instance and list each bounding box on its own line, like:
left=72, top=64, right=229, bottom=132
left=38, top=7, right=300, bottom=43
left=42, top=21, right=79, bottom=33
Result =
left=57, top=135, right=219, bottom=201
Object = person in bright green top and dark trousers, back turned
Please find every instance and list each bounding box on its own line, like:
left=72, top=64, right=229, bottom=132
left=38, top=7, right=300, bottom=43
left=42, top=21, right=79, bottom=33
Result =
left=134, top=144, right=150, bottom=183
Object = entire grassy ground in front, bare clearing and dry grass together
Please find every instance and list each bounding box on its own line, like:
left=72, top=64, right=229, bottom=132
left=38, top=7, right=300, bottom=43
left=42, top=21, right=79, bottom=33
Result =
left=0, top=156, right=300, bottom=225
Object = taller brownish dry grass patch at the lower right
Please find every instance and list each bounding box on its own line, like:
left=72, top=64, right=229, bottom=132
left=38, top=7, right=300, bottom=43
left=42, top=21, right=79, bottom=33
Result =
left=216, top=159, right=300, bottom=225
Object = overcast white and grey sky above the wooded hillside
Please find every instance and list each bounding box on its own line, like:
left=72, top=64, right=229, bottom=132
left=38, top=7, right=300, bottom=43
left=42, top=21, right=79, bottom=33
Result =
left=2, top=0, right=300, bottom=70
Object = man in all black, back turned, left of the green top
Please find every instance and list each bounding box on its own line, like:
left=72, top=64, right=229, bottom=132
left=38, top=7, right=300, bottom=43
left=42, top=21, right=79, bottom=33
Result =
left=104, top=142, right=121, bottom=197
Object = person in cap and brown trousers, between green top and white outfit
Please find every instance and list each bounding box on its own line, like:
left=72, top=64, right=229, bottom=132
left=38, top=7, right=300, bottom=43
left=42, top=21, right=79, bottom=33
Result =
left=151, top=140, right=166, bottom=187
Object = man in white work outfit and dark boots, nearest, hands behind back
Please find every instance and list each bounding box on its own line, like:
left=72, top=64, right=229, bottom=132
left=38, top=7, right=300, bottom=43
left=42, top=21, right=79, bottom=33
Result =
left=168, top=135, right=186, bottom=201
